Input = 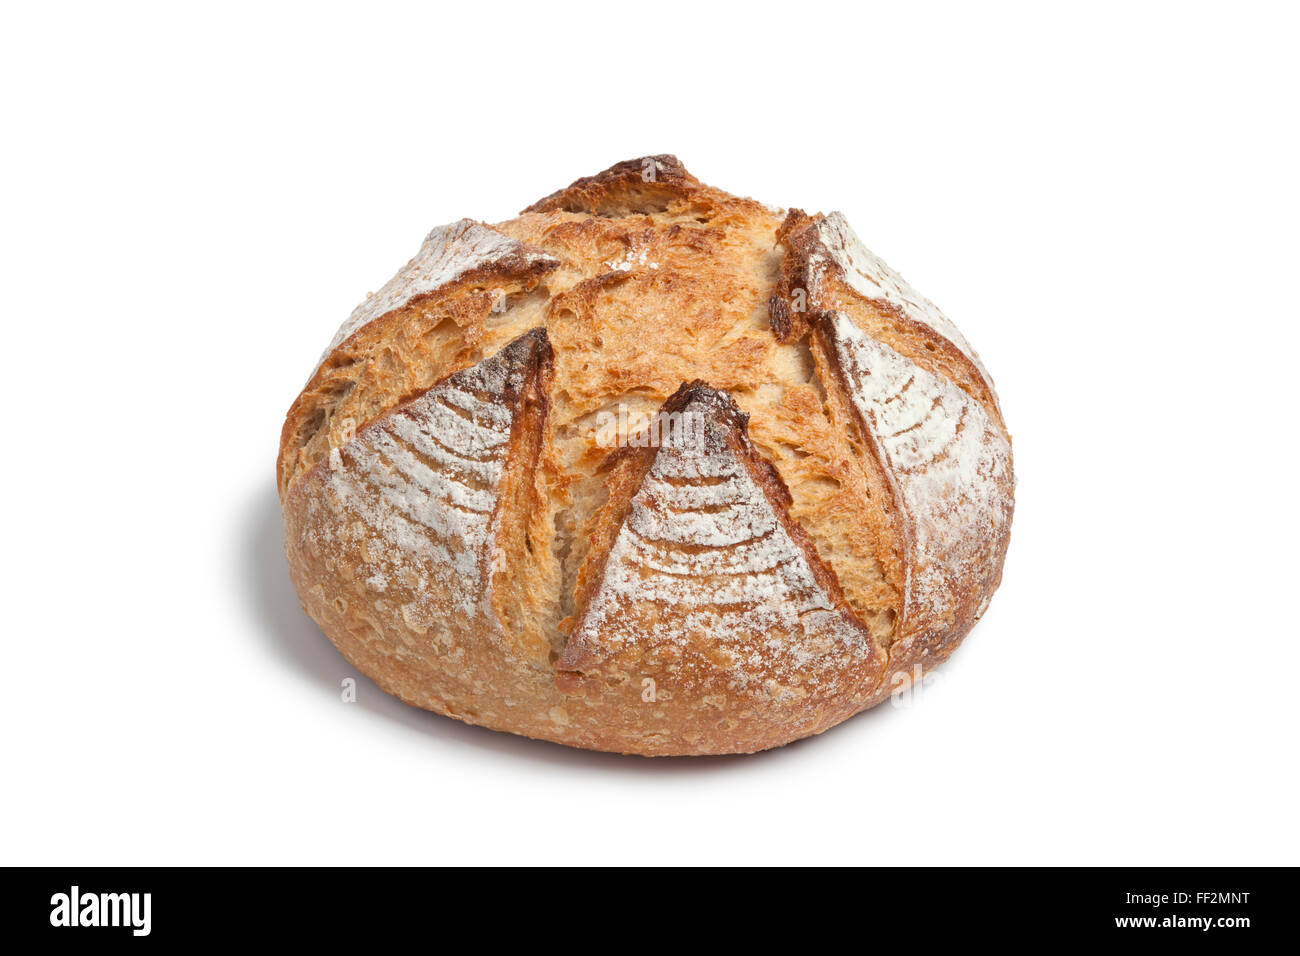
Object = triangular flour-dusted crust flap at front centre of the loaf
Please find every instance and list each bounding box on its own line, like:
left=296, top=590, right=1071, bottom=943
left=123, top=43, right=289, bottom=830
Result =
left=559, top=388, right=874, bottom=697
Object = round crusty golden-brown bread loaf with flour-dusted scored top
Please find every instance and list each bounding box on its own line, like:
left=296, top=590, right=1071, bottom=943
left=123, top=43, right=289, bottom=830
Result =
left=278, top=156, right=1014, bottom=756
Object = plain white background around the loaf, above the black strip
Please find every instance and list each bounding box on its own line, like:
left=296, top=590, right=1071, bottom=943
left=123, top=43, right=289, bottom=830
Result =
left=0, top=0, right=1300, bottom=865
